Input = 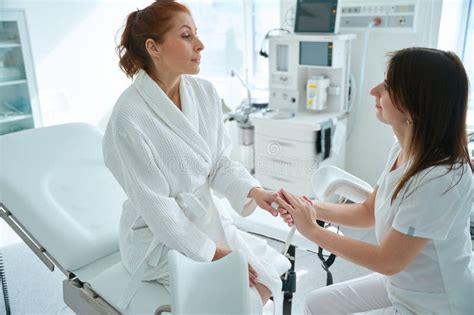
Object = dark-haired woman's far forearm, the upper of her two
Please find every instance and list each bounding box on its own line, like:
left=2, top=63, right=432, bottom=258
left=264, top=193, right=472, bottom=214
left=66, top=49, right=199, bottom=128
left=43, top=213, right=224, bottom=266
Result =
left=313, top=202, right=375, bottom=228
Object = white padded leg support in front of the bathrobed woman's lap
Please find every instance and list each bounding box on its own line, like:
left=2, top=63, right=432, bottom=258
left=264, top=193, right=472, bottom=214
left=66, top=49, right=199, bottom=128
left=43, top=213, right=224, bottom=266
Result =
left=168, top=250, right=250, bottom=315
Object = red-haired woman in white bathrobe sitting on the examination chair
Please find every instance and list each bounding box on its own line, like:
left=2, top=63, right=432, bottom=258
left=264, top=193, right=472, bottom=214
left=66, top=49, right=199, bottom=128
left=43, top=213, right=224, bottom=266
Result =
left=103, top=0, right=290, bottom=312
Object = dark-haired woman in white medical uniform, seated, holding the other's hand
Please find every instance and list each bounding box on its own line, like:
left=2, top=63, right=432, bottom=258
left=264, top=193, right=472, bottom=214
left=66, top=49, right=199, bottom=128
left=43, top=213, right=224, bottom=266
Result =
left=278, top=48, right=474, bottom=314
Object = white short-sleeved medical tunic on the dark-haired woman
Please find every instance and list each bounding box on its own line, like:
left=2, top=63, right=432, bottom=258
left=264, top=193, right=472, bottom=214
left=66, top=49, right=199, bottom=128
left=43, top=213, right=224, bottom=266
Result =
left=375, top=143, right=474, bottom=314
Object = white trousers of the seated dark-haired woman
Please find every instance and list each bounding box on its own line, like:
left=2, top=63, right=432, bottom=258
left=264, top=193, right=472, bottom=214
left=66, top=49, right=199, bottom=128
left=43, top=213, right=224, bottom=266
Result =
left=305, top=273, right=395, bottom=315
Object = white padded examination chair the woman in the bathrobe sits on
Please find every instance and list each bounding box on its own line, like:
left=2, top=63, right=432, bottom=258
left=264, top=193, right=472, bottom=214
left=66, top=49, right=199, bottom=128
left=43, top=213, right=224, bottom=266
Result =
left=0, top=124, right=248, bottom=314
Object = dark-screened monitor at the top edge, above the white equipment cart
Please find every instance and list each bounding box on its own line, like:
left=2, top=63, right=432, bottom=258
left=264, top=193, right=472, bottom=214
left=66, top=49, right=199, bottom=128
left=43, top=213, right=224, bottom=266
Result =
left=295, top=0, right=338, bottom=33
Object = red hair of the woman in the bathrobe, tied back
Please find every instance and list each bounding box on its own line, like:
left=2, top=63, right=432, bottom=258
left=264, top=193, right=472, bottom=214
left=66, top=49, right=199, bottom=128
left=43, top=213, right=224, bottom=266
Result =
left=117, top=0, right=191, bottom=78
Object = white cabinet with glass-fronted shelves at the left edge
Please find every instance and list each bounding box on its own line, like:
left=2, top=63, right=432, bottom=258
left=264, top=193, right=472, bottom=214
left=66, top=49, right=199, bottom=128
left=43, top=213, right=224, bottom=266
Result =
left=0, top=9, right=41, bottom=135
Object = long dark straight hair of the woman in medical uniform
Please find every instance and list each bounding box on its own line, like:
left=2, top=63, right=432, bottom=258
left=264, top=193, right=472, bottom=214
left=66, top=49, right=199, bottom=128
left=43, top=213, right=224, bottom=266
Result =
left=386, top=48, right=472, bottom=202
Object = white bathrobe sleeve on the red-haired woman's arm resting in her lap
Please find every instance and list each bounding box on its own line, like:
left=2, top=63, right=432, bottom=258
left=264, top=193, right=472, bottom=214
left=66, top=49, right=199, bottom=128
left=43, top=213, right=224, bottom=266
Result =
left=104, top=117, right=216, bottom=262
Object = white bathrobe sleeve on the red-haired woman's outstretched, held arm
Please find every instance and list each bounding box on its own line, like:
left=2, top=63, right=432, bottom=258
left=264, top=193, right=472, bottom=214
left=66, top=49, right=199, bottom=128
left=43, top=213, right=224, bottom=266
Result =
left=209, top=85, right=261, bottom=216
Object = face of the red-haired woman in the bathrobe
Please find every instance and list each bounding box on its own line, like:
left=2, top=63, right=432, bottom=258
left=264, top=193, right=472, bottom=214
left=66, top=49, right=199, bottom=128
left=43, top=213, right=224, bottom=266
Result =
left=157, top=12, right=204, bottom=76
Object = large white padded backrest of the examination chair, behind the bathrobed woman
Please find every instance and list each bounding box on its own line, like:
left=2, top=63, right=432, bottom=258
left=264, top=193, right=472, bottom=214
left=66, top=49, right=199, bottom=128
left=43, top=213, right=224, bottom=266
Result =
left=0, top=124, right=125, bottom=271
